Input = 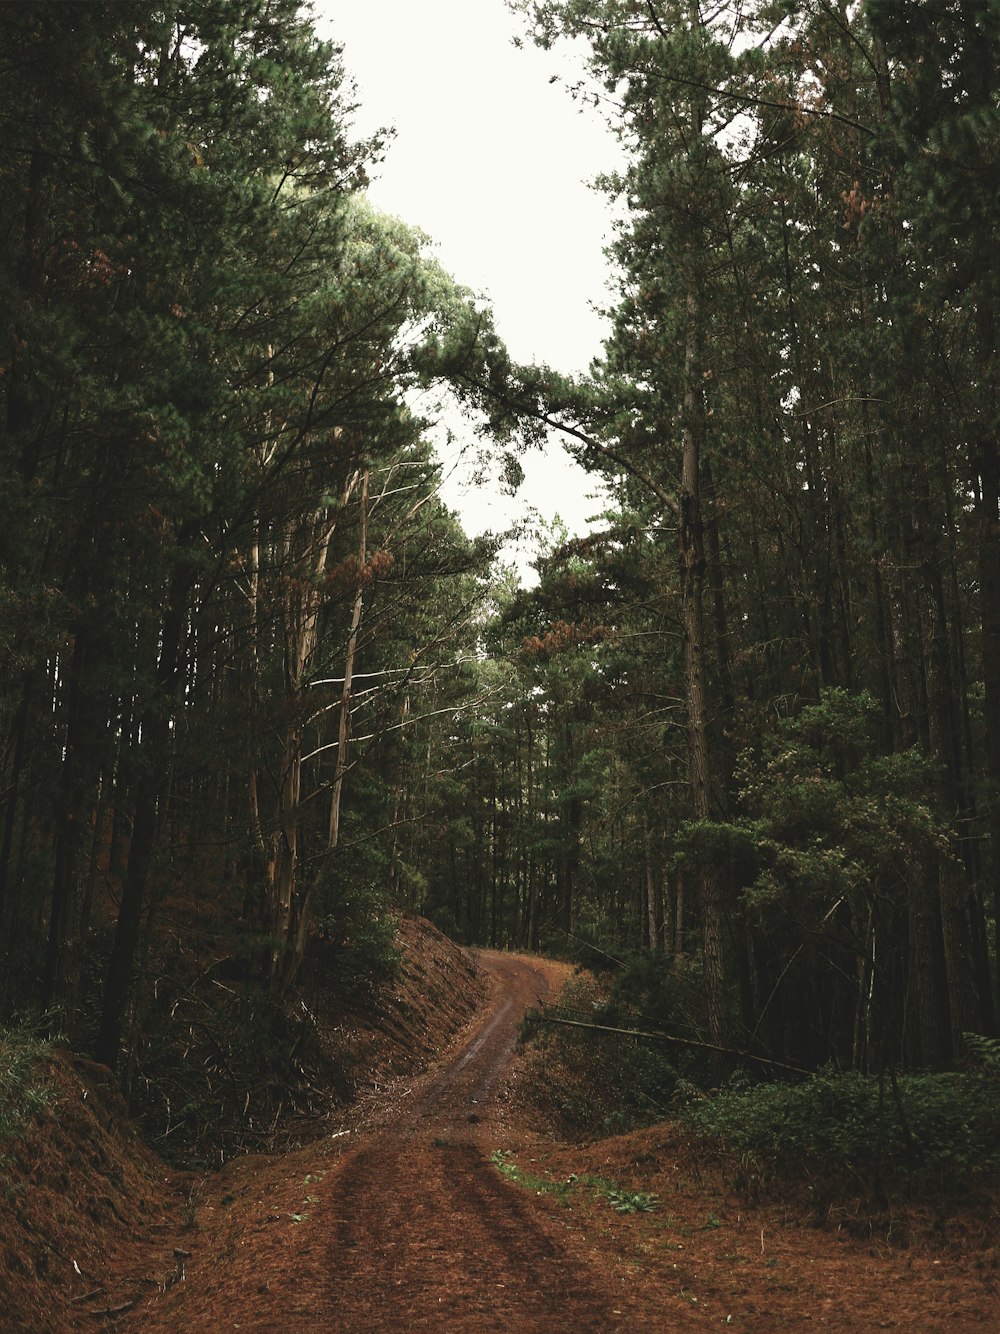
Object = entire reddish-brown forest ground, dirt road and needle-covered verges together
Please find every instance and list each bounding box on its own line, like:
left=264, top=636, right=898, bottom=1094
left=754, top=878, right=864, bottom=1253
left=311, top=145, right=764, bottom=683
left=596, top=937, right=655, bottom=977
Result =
left=0, top=933, right=1000, bottom=1334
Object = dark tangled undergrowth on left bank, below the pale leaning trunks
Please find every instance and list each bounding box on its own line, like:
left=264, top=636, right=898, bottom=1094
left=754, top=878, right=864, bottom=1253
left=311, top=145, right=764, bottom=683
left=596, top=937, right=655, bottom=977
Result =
left=123, top=888, right=400, bottom=1166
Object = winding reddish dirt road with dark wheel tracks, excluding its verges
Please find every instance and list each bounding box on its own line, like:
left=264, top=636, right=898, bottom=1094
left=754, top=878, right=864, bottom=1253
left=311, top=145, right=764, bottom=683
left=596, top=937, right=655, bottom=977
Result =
left=308, top=958, right=613, bottom=1330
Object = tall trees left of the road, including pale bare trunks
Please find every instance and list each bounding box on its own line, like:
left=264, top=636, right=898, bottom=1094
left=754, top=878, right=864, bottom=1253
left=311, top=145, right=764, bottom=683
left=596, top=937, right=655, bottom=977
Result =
left=0, top=0, right=501, bottom=1065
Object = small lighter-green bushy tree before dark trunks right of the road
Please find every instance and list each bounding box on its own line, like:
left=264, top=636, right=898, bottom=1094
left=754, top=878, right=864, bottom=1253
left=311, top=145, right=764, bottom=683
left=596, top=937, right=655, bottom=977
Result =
left=673, top=687, right=955, bottom=1066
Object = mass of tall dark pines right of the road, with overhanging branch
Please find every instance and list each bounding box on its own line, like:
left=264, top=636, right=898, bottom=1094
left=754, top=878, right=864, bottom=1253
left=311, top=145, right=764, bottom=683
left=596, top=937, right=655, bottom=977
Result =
left=416, top=0, right=1000, bottom=1069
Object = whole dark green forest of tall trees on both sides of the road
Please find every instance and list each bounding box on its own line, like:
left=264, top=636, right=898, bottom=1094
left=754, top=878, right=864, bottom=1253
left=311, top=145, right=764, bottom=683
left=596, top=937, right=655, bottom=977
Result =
left=0, top=0, right=1000, bottom=1141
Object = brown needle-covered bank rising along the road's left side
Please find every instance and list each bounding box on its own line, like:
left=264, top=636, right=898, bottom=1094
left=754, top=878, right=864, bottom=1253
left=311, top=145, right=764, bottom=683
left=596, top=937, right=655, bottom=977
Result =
left=0, top=916, right=484, bottom=1334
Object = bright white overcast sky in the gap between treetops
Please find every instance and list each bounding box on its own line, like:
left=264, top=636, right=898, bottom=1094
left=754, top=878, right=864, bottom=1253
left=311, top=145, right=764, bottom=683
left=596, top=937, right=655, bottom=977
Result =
left=313, top=0, right=617, bottom=562
